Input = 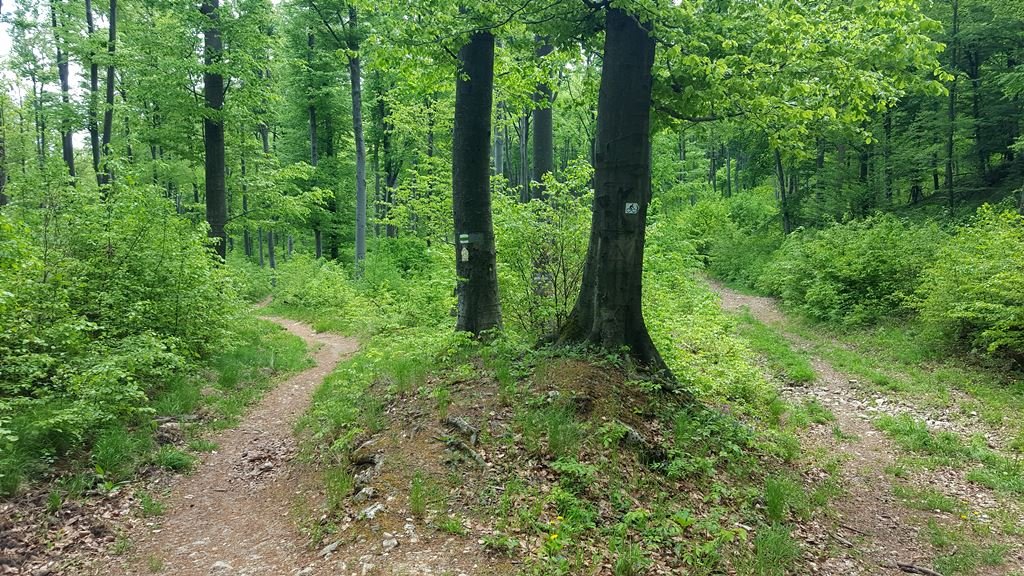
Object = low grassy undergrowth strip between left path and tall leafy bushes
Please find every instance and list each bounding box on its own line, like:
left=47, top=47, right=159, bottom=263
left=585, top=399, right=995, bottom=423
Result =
left=0, top=318, right=310, bottom=498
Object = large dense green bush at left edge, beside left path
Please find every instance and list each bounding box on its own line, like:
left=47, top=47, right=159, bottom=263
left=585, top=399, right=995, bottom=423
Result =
left=0, top=187, right=242, bottom=493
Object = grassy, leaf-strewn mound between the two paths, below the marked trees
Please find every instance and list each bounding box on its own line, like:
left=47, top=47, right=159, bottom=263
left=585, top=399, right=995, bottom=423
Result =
left=273, top=238, right=841, bottom=575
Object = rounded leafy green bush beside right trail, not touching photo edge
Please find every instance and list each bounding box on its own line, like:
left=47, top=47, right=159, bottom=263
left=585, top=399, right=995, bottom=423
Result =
left=758, top=214, right=947, bottom=325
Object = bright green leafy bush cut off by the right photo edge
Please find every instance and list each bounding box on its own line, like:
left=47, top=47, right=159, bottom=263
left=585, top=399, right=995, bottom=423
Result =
left=918, top=206, right=1024, bottom=361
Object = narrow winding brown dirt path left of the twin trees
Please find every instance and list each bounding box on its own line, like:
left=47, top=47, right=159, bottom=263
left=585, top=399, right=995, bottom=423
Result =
left=96, top=317, right=358, bottom=576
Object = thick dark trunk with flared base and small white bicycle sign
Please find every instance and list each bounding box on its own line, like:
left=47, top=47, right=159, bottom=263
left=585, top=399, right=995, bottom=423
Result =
left=559, top=8, right=671, bottom=378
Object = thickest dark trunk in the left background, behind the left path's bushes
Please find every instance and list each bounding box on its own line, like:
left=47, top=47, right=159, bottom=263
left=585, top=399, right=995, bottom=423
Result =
left=201, top=0, right=227, bottom=258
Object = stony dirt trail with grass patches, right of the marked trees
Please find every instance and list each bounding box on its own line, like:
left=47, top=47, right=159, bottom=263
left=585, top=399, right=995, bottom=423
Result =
left=710, top=281, right=1019, bottom=576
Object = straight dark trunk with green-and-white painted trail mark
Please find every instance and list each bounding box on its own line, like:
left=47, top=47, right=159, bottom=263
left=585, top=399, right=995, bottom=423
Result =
left=452, top=32, right=502, bottom=336
